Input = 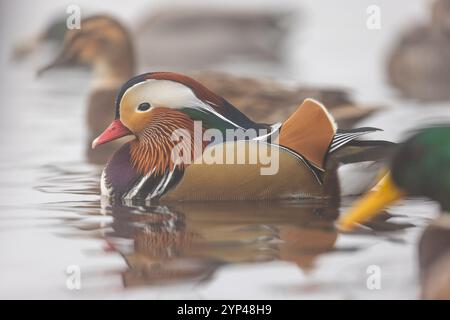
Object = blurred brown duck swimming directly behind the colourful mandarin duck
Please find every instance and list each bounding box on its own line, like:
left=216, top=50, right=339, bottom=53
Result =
left=40, top=15, right=378, bottom=163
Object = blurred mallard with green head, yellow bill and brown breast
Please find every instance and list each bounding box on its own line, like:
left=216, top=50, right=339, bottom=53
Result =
left=338, top=126, right=450, bottom=299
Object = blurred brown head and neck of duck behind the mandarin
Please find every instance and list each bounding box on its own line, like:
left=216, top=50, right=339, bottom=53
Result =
left=39, top=16, right=136, bottom=163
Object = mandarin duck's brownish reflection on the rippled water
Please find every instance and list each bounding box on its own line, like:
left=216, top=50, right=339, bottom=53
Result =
left=97, top=202, right=338, bottom=287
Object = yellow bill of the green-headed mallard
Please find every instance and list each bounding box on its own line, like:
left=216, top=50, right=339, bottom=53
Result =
left=338, top=173, right=405, bottom=231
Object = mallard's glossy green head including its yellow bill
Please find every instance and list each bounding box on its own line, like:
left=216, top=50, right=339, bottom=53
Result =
left=338, top=126, right=450, bottom=230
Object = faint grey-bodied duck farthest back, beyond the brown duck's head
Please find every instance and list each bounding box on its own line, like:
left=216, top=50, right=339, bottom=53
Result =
left=13, top=7, right=297, bottom=70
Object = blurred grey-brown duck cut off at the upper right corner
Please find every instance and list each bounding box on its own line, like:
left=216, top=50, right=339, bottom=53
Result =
left=388, top=0, right=450, bottom=101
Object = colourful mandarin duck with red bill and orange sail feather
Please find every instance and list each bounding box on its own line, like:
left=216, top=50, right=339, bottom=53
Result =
left=92, top=72, right=391, bottom=201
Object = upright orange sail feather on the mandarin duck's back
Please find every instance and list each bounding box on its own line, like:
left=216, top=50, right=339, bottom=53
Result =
left=279, top=99, right=337, bottom=170
